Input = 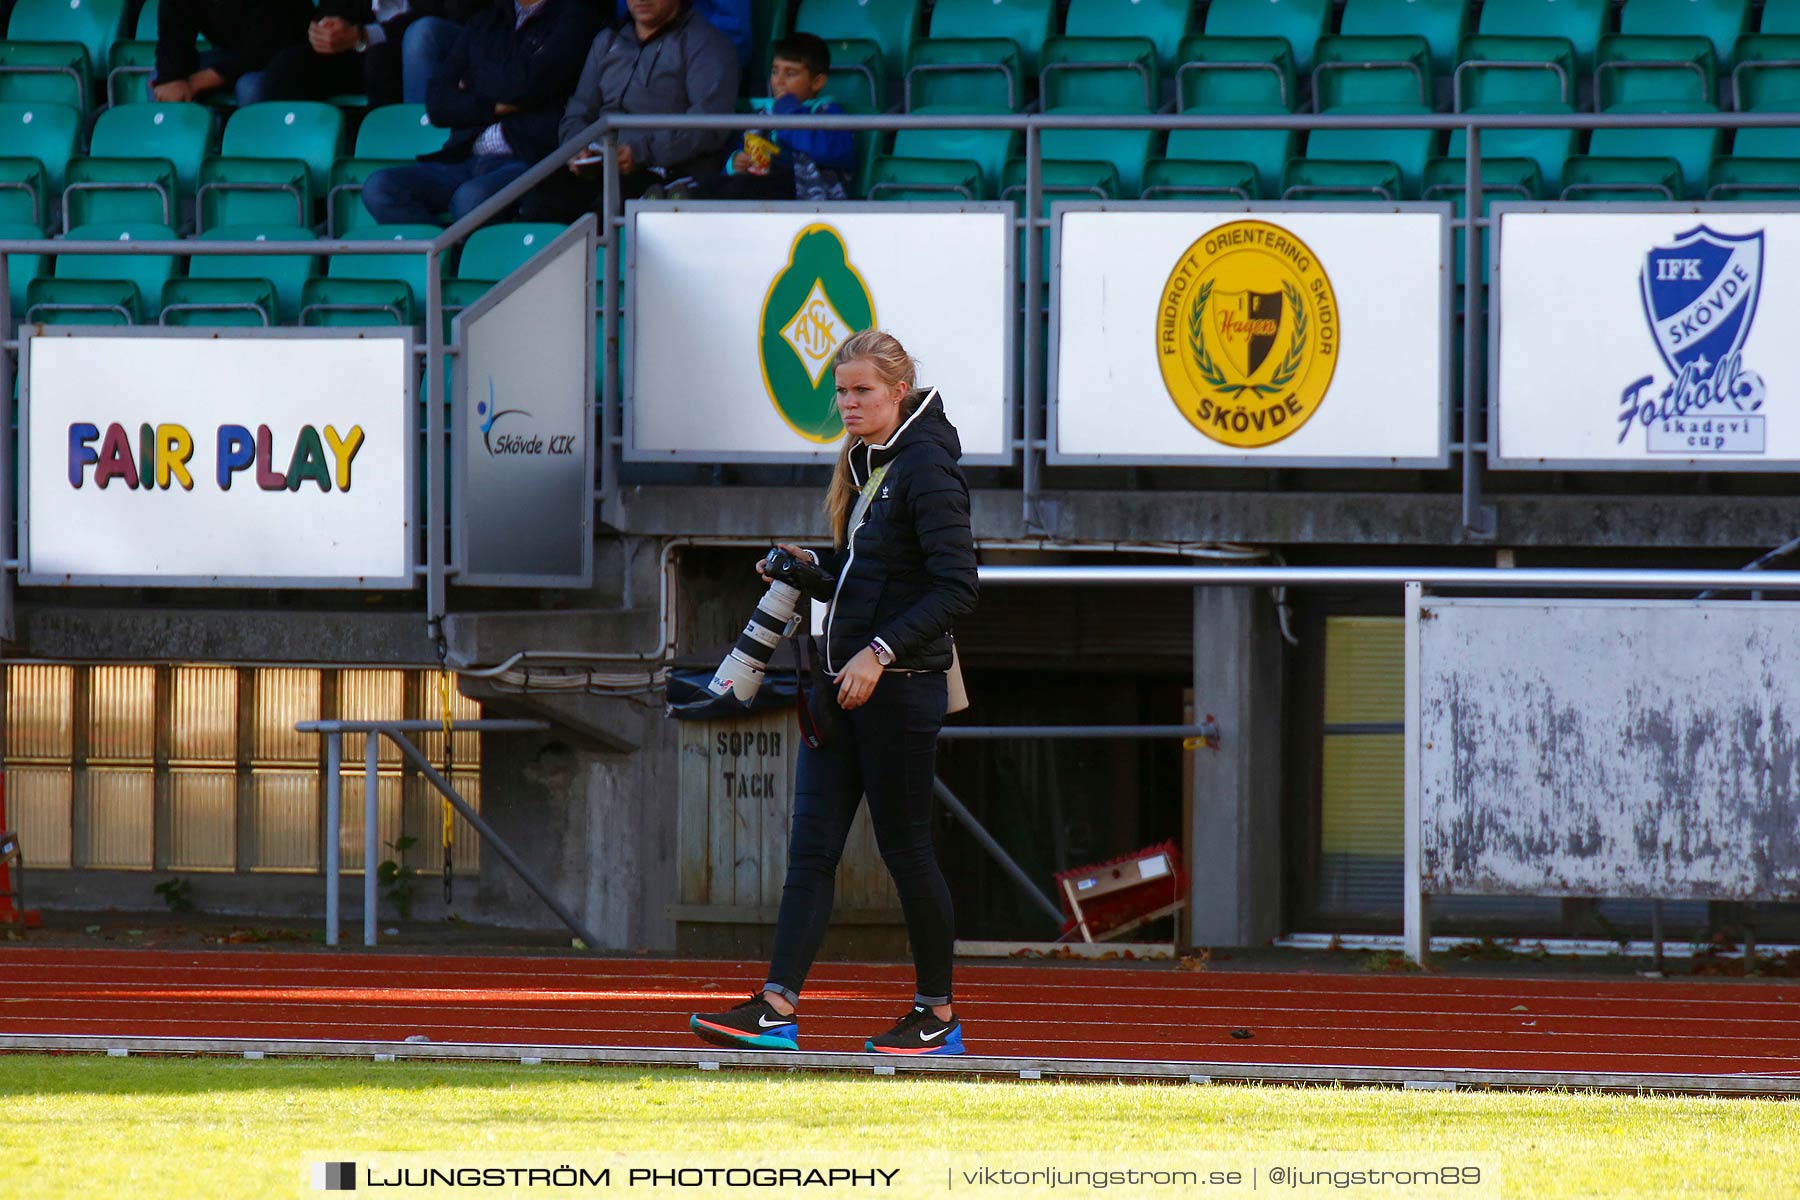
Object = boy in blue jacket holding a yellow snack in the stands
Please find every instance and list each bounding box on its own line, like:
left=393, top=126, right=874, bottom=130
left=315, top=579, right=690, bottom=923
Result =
left=707, top=34, right=857, bottom=200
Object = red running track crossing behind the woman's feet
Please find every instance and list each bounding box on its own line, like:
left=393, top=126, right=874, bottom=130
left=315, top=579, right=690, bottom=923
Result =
left=0, top=946, right=1800, bottom=1078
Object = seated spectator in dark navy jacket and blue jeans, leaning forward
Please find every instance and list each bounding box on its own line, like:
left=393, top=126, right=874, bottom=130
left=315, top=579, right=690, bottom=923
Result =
left=362, top=0, right=599, bottom=225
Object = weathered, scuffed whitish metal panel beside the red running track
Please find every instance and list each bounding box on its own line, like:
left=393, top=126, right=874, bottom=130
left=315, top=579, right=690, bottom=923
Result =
left=1409, top=597, right=1800, bottom=900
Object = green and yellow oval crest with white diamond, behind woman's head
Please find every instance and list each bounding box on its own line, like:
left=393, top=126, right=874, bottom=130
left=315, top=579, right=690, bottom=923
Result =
left=758, top=225, right=875, bottom=443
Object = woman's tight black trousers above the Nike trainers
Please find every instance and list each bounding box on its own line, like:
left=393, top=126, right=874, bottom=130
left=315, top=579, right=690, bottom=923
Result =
left=769, top=673, right=956, bottom=1004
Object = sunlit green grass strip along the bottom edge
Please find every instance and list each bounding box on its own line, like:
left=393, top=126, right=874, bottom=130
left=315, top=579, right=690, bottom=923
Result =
left=0, top=1054, right=1800, bottom=1200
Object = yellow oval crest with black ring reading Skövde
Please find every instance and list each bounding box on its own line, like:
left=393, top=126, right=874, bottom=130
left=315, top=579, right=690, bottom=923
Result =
left=1156, top=221, right=1339, bottom=450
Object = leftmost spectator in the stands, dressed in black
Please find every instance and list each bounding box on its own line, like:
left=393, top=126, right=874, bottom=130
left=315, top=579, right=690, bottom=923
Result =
left=151, top=0, right=313, bottom=104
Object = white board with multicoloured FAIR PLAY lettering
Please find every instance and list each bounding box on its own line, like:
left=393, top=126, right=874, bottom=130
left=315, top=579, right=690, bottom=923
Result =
left=20, top=329, right=418, bottom=588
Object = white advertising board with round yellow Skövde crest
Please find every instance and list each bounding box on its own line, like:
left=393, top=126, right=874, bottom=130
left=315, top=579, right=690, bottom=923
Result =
left=1049, top=203, right=1449, bottom=468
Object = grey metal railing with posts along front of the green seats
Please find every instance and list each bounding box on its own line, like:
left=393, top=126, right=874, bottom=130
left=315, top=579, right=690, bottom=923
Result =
left=0, top=112, right=1800, bottom=635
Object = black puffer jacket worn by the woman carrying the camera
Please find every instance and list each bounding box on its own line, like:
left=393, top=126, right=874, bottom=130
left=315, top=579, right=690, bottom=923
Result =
left=824, top=389, right=977, bottom=671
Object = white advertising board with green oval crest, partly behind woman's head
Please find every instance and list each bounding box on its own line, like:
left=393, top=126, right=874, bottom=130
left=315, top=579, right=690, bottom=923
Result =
left=625, top=203, right=1015, bottom=464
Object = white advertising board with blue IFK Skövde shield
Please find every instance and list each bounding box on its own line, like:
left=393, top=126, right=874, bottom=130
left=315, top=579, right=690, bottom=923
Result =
left=1489, top=203, right=1800, bottom=471
